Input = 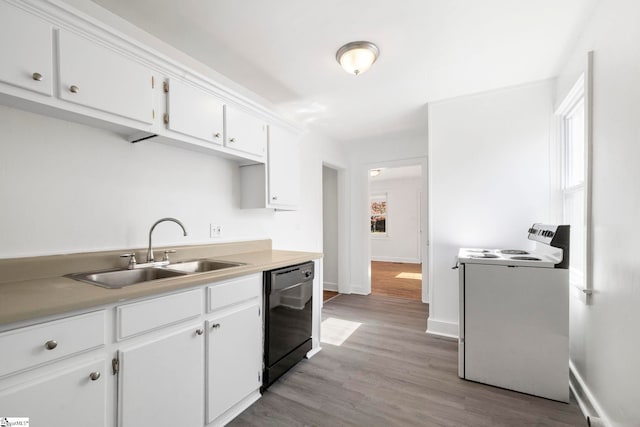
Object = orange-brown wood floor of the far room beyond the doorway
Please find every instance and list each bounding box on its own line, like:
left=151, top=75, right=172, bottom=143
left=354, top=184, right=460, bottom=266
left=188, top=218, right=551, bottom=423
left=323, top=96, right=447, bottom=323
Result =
left=371, top=261, right=422, bottom=301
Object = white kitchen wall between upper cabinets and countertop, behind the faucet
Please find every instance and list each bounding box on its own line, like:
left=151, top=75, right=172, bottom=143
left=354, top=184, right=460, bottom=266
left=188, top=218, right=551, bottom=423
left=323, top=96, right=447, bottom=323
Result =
left=0, top=106, right=339, bottom=258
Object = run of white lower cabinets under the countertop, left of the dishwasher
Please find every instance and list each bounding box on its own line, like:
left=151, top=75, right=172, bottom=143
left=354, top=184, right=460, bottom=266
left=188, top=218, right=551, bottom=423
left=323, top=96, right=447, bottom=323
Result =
left=0, top=273, right=262, bottom=427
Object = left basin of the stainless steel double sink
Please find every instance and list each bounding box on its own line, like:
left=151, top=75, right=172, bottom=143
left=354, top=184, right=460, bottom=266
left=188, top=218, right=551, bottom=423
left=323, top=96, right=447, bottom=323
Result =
left=67, top=267, right=187, bottom=289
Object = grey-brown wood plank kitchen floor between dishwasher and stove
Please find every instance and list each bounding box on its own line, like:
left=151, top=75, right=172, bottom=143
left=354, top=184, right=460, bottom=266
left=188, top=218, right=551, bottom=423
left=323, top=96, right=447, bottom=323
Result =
left=230, top=295, right=586, bottom=427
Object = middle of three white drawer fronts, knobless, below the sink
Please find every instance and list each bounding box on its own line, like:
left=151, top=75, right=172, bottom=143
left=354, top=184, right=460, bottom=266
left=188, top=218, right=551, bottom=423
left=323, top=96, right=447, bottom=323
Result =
left=116, top=289, right=202, bottom=341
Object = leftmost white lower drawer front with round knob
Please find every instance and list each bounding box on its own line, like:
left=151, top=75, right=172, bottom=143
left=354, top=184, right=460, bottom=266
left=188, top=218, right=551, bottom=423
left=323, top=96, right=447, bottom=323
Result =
left=0, top=311, right=105, bottom=377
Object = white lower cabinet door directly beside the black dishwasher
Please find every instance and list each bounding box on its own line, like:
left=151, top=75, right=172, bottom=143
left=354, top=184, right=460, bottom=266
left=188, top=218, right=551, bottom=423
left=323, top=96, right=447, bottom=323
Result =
left=207, top=304, right=262, bottom=423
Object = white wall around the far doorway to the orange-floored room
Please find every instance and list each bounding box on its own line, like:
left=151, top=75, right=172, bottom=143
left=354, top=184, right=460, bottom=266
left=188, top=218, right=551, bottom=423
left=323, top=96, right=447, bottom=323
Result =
left=341, top=125, right=429, bottom=302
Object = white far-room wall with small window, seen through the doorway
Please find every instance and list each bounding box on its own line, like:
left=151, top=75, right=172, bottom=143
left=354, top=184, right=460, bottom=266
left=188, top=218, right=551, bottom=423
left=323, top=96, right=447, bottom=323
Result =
left=369, top=177, right=422, bottom=264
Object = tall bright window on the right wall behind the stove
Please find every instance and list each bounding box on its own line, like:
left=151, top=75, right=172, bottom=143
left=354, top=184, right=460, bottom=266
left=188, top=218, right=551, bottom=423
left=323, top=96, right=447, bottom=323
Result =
left=559, top=79, right=587, bottom=288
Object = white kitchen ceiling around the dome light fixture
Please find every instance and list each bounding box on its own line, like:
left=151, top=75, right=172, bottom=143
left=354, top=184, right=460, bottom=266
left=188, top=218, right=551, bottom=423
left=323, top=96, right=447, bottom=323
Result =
left=89, top=0, right=598, bottom=141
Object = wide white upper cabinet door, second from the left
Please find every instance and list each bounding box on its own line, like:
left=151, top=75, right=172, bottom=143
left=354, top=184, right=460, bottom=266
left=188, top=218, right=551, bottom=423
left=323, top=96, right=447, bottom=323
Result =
left=58, top=30, right=153, bottom=124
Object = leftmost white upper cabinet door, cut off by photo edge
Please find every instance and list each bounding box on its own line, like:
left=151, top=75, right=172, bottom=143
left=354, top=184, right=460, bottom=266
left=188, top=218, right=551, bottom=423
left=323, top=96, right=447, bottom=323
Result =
left=0, top=2, right=53, bottom=96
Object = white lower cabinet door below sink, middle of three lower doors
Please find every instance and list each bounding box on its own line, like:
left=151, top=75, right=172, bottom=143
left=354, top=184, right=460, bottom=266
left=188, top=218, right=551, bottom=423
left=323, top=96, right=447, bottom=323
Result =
left=118, top=325, right=204, bottom=427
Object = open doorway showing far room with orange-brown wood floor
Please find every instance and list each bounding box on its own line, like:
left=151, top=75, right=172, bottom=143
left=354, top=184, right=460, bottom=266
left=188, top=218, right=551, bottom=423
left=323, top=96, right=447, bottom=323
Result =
left=369, top=164, right=426, bottom=302
